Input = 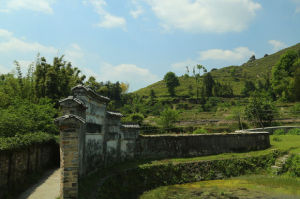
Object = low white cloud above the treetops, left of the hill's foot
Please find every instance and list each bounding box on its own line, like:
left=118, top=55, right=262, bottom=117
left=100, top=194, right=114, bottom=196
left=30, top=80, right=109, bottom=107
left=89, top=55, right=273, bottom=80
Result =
left=97, top=64, right=160, bottom=91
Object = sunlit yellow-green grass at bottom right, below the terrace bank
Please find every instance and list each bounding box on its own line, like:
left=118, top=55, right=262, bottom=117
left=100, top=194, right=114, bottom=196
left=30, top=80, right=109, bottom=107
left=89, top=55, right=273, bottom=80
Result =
left=140, top=175, right=300, bottom=199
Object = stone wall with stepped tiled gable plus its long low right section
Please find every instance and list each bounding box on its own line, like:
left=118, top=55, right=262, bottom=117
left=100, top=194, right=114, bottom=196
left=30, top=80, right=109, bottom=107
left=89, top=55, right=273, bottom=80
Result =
left=56, top=85, right=270, bottom=198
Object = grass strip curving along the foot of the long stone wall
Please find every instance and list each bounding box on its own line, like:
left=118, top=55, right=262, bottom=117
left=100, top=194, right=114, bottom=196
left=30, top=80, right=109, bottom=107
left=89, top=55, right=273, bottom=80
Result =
left=79, top=135, right=300, bottom=198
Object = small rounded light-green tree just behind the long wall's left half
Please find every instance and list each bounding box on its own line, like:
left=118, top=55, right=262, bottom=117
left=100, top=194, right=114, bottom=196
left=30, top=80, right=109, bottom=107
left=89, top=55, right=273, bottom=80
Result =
left=159, top=108, right=179, bottom=130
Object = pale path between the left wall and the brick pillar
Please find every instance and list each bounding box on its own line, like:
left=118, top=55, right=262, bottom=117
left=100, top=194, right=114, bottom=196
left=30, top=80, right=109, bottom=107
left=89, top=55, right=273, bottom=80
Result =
left=19, top=168, right=60, bottom=199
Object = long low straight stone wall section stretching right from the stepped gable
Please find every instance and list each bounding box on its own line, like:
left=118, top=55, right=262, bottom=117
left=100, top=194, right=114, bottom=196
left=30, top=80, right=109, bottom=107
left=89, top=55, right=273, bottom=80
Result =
left=136, top=132, right=270, bottom=158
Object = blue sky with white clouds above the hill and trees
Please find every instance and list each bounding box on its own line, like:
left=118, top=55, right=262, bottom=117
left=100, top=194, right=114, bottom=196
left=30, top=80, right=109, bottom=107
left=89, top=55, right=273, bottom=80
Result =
left=0, top=0, right=300, bottom=91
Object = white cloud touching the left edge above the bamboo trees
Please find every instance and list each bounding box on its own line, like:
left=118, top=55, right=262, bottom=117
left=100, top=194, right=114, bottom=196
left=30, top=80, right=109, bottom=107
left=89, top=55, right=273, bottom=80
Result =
left=0, top=29, right=58, bottom=54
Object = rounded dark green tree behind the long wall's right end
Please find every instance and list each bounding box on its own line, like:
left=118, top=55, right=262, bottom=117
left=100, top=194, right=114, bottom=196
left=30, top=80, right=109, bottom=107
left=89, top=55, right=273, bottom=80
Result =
left=245, top=92, right=277, bottom=127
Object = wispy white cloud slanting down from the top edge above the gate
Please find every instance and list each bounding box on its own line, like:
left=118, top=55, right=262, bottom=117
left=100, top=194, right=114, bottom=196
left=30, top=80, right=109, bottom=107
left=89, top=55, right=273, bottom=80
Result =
left=83, top=0, right=126, bottom=29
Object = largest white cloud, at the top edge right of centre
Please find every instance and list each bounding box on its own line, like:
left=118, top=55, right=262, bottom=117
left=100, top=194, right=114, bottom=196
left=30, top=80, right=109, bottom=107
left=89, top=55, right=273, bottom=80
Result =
left=146, top=0, right=261, bottom=33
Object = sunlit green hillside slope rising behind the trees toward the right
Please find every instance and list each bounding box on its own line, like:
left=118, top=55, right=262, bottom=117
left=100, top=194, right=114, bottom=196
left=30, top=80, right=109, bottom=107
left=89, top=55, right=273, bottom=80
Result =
left=134, top=43, right=300, bottom=97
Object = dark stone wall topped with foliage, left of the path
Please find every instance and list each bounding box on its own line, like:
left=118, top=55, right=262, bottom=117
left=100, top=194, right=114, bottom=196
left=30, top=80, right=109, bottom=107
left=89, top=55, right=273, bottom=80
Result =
left=0, top=141, right=59, bottom=198
